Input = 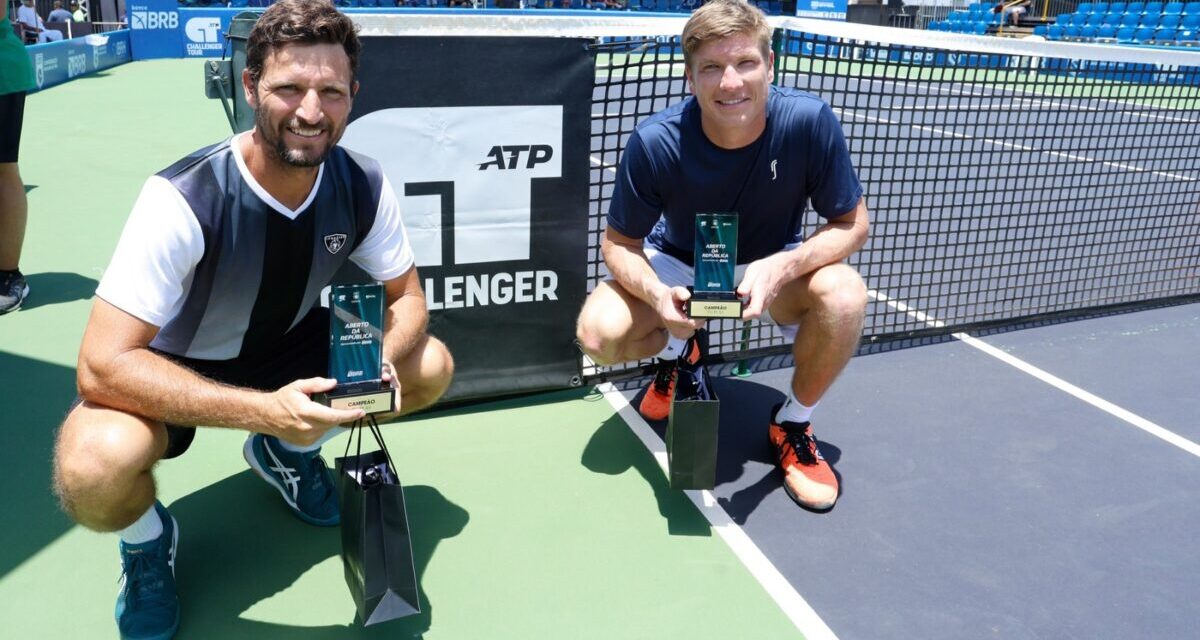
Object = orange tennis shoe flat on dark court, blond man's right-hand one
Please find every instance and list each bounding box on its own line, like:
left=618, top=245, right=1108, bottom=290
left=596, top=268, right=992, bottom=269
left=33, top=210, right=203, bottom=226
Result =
left=768, top=405, right=838, bottom=512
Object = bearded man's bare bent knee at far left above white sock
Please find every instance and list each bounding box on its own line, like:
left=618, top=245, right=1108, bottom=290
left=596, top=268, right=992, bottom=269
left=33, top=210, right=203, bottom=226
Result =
left=53, top=403, right=167, bottom=531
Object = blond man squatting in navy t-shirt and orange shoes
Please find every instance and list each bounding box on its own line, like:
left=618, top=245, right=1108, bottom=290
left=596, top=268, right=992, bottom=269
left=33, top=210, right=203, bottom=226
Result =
left=577, top=0, right=868, bottom=510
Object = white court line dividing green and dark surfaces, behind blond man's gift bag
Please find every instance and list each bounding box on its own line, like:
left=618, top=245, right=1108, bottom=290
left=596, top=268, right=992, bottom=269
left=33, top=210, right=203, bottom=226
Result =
left=596, top=382, right=838, bottom=640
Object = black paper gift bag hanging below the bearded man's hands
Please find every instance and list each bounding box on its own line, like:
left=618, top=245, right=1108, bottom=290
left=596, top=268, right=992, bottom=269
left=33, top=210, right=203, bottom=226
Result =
left=336, top=415, right=421, bottom=626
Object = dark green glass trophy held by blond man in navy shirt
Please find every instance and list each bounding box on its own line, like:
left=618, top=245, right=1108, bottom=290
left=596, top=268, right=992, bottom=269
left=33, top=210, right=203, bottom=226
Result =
left=688, top=214, right=742, bottom=318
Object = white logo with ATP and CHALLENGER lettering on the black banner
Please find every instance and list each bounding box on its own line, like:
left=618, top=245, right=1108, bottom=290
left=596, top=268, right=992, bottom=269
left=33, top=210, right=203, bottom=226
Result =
left=342, top=106, right=563, bottom=310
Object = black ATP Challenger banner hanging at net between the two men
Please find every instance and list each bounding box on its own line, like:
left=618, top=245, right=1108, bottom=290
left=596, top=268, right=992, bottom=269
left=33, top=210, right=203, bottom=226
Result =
left=342, top=37, right=594, bottom=400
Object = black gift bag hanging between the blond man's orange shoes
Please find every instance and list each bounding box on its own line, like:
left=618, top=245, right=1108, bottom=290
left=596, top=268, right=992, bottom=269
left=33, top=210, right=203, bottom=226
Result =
left=666, top=365, right=721, bottom=489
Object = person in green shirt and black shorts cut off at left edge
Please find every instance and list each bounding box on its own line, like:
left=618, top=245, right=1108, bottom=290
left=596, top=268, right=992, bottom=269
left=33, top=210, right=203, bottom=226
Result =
left=0, top=2, right=34, bottom=313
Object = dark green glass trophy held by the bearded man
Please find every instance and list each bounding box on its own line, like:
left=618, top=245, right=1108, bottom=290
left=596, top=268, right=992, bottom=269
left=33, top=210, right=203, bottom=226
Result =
left=316, top=282, right=396, bottom=413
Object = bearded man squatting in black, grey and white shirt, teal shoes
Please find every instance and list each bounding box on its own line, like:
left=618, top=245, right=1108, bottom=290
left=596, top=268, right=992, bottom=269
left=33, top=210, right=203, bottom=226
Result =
left=46, top=0, right=454, bottom=639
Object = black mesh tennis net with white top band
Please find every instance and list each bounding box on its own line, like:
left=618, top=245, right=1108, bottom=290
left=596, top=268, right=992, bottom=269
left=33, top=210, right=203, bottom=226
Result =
left=592, top=19, right=1200, bottom=377
